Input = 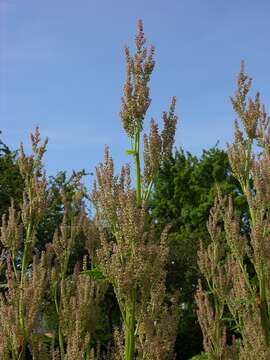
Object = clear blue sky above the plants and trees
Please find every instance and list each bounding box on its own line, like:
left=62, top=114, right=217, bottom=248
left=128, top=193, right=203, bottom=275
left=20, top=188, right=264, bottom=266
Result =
left=0, top=0, right=270, bottom=181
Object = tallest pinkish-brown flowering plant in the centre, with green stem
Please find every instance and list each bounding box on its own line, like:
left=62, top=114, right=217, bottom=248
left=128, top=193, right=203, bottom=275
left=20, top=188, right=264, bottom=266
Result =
left=92, top=21, right=177, bottom=360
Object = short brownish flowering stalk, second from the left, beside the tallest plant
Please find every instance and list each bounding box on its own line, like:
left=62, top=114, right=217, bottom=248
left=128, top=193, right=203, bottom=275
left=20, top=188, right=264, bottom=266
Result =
left=47, top=181, right=104, bottom=360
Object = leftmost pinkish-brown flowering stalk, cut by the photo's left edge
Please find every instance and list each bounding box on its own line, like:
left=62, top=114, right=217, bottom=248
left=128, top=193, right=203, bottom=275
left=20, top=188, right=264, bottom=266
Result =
left=0, top=128, right=47, bottom=360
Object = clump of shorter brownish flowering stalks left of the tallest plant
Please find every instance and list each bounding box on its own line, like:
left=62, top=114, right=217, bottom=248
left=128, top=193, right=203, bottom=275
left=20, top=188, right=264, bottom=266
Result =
left=0, top=129, right=104, bottom=360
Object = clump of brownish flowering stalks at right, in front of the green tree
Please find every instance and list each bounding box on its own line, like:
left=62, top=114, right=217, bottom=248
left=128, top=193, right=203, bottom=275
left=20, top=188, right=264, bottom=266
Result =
left=196, top=63, right=270, bottom=360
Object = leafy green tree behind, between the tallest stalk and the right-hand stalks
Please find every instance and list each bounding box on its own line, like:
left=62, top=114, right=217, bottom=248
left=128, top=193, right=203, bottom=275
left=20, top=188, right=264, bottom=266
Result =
left=151, top=147, right=245, bottom=359
